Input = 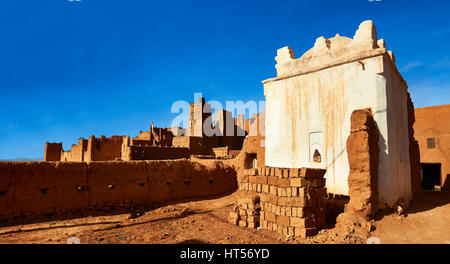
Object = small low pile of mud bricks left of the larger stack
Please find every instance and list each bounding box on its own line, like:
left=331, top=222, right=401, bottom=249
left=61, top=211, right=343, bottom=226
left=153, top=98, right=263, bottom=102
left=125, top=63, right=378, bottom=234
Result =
left=229, top=195, right=261, bottom=228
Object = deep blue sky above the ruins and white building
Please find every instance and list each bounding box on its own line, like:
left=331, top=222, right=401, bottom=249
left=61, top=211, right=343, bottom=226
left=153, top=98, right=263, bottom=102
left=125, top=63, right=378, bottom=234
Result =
left=0, top=0, right=450, bottom=159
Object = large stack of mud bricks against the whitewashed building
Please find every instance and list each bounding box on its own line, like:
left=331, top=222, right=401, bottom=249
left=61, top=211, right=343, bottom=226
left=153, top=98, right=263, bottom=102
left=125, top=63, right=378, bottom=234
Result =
left=234, top=167, right=327, bottom=238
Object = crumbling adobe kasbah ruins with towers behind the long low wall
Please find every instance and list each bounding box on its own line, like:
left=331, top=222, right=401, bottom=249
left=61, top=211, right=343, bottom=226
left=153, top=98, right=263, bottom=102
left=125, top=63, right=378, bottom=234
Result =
left=44, top=98, right=264, bottom=161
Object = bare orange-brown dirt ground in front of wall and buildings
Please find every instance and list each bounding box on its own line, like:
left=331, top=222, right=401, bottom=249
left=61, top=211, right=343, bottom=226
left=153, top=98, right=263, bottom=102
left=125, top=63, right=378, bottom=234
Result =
left=0, top=192, right=450, bottom=244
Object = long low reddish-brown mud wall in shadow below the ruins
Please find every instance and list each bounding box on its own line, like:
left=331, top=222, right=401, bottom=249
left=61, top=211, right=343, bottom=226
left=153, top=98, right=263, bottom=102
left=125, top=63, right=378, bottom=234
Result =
left=0, top=160, right=237, bottom=220
